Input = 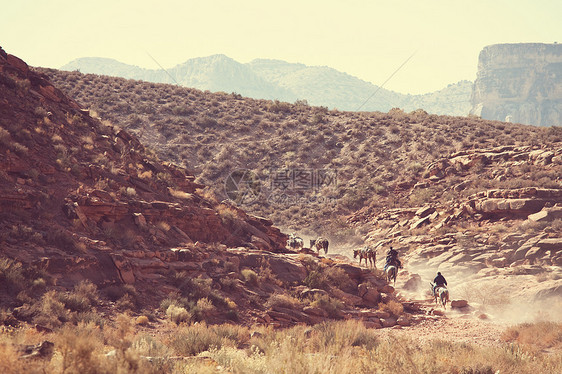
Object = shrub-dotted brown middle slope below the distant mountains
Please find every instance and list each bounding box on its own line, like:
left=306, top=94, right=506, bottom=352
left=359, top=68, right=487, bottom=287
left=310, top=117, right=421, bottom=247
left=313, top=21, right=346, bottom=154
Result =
left=39, top=66, right=562, bottom=240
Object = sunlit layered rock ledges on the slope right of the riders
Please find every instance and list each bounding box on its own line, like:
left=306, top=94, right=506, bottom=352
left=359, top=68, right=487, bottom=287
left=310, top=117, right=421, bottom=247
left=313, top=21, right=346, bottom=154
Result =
left=350, top=143, right=562, bottom=310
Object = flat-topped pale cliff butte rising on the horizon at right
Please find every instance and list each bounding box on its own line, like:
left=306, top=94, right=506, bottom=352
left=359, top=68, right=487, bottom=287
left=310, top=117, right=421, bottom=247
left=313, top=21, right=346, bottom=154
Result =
left=471, top=43, right=562, bottom=126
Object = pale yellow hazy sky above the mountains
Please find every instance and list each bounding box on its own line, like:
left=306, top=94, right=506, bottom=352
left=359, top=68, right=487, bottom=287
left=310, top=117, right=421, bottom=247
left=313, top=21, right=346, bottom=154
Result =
left=0, top=0, right=562, bottom=93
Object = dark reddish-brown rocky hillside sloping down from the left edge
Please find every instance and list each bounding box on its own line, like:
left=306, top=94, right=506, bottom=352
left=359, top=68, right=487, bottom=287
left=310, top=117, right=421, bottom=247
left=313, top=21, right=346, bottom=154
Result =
left=0, top=51, right=425, bottom=332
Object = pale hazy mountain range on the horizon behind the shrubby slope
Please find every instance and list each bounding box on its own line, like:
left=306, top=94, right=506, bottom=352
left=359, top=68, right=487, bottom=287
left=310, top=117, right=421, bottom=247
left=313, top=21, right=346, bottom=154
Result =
left=61, top=55, right=473, bottom=116
